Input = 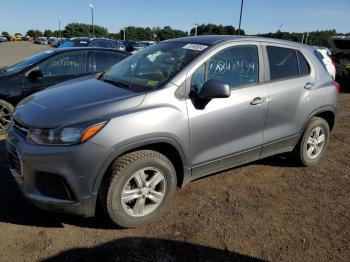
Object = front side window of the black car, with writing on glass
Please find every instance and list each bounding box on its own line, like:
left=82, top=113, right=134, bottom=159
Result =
left=39, top=52, right=87, bottom=77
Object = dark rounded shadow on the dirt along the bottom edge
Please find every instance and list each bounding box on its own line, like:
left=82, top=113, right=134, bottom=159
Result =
left=43, top=237, right=264, bottom=262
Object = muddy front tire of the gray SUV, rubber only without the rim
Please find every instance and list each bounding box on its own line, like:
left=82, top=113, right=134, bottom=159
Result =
left=99, top=150, right=176, bottom=228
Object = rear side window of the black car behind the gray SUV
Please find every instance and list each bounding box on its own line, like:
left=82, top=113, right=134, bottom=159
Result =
left=92, top=50, right=127, bottom=73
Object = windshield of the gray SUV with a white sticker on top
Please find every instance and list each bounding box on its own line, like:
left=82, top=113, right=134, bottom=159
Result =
left=103, top=42, right=208, bottom=89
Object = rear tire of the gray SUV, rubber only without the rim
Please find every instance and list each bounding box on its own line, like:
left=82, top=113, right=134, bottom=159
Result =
left=293, top=117, right=330, bottom=166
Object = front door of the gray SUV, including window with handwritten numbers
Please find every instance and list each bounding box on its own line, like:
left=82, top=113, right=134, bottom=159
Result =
left=186, top=43, right=268, bottom=178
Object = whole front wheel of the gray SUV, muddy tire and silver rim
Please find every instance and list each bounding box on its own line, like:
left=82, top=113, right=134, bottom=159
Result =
left=99, top=150, right=176, bottom=228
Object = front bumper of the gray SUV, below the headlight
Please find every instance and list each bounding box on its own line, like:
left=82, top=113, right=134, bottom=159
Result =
left=7, top=128, right=111, bottom=217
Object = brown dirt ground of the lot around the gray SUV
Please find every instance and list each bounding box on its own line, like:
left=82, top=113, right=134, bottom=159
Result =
left=0, top=42, right=350, bottom=261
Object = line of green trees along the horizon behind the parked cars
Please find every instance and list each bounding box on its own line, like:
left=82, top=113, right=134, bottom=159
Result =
left=2, top=23, right=350, bottom=46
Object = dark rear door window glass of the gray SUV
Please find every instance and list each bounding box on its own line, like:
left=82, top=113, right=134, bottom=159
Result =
left=266, top=46, right=299, bottom=81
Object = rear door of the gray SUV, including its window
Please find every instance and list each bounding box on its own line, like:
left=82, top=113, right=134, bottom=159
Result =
left=261, top=43, right=314, bottom=157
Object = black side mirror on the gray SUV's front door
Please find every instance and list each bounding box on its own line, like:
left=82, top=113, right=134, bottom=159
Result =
left=198, top=80, right=231, bottom=100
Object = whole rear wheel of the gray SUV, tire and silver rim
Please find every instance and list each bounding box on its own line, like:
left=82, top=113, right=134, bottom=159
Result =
left=294, top=117, right=330, bottom=166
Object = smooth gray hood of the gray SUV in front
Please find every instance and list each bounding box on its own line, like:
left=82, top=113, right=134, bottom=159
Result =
left=13, top=79, right=145, bottom=128
